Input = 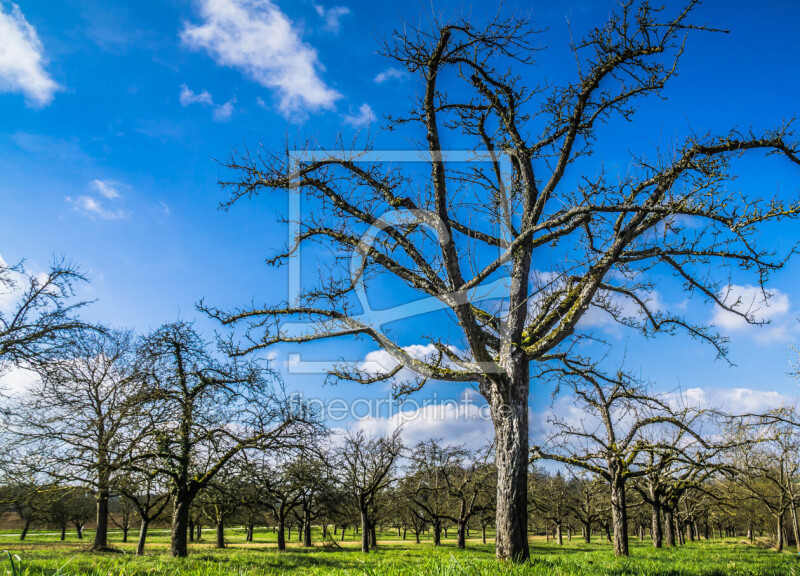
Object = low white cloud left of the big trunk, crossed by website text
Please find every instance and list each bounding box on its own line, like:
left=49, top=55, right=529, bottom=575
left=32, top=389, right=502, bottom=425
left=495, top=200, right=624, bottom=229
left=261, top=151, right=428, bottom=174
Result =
left=352, top=388, right=494, bottom=448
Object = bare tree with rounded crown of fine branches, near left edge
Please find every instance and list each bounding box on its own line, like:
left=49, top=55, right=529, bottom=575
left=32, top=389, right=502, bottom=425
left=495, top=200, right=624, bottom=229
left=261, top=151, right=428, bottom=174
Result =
left=8, top=331, right=147, bottom=549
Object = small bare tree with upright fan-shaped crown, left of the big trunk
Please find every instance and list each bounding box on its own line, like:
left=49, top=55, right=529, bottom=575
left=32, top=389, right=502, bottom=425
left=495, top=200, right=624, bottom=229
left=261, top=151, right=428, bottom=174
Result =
left=337, top=429, right=403, bottom=553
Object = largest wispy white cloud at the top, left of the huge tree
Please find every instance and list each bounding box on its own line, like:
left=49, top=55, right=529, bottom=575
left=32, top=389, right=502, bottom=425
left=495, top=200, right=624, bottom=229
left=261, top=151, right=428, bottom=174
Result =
left=181, top=0, right=340, bottom=116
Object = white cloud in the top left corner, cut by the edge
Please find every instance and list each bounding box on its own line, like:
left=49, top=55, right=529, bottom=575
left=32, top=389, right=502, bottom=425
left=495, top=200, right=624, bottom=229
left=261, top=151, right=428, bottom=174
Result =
left=0, top=0, right=60, bottom=106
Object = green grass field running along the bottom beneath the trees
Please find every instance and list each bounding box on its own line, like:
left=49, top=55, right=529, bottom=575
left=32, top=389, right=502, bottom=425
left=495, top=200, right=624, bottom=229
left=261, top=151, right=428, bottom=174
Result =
left=0, top=530, right=800, bottom=576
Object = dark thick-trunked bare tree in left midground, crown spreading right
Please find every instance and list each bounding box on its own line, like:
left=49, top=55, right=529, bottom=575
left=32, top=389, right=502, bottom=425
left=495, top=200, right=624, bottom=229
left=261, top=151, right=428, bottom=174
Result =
left=134, top=322, right=314, bottom=556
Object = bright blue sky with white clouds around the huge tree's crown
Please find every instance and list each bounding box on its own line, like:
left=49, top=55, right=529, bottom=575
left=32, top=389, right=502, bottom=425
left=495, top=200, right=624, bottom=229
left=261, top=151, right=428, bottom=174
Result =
left=0, top=0, right=800, bottom=446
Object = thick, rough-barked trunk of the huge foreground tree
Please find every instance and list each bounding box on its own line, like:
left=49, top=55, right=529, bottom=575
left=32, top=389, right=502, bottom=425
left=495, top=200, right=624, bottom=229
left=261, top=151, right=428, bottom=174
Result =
left=489, top=384, right=530, bottom=562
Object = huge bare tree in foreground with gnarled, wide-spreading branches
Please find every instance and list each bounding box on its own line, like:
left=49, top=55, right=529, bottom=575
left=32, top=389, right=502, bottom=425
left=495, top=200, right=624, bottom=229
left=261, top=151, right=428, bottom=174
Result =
left=201, top=0, right=800, bottom=560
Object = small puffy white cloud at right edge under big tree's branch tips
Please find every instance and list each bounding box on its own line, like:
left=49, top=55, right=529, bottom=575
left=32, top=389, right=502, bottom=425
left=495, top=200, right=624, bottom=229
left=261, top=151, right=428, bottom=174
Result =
left=711, top=284, right=798, bottom=342
